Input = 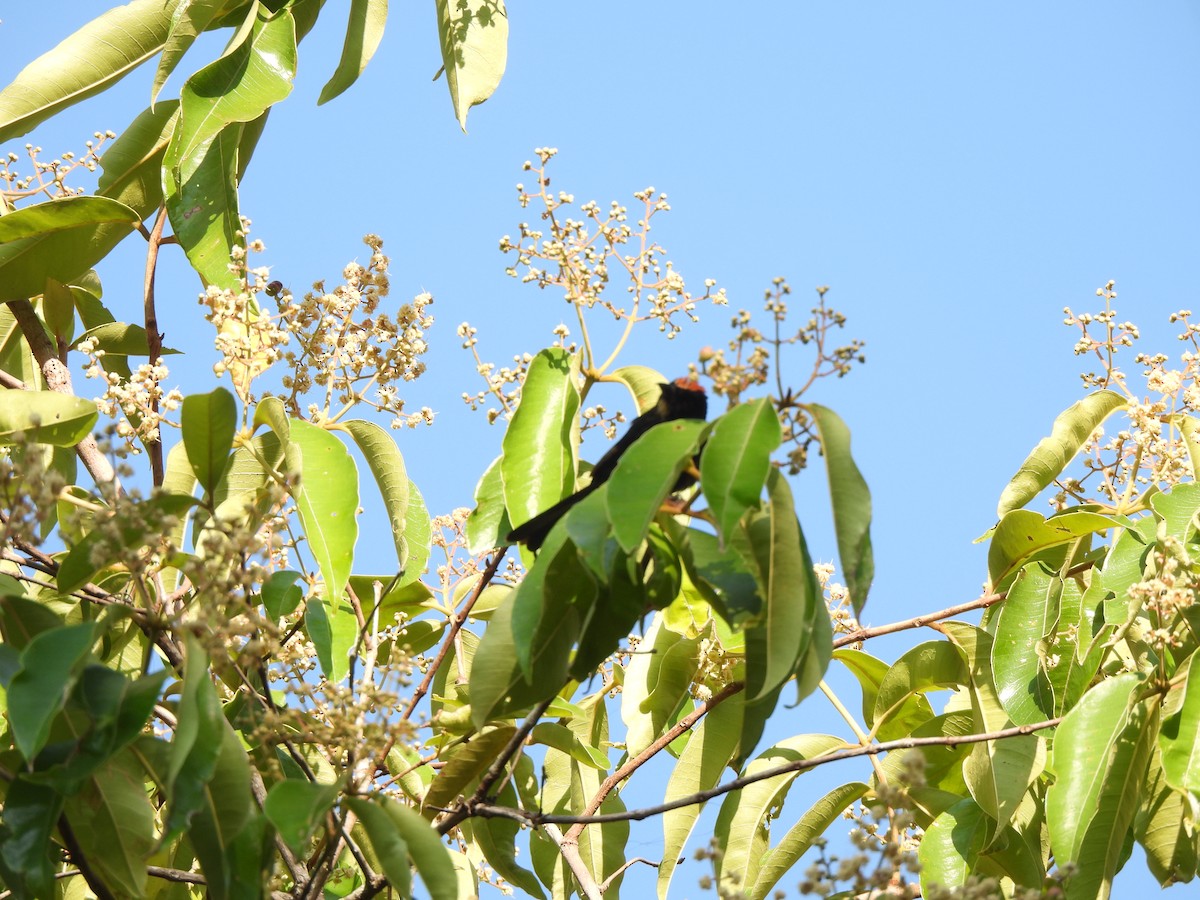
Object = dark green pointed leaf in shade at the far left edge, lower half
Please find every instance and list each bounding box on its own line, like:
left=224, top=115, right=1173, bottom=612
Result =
left=7, top=622, right=96, bottom=762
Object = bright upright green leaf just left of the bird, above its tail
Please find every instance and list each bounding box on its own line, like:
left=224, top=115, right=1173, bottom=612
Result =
left=500, top=348, right=580, bottom=524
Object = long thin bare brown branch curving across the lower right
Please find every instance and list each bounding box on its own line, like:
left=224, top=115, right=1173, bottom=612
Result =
left=470, top=716, right=1063, bottom=826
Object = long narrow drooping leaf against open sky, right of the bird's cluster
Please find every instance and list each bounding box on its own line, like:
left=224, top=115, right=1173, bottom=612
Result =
left=806, top=403, right=875, bottom=616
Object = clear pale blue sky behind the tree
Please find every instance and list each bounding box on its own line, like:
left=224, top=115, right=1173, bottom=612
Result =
left=0, top=0, right=1200, bottom=896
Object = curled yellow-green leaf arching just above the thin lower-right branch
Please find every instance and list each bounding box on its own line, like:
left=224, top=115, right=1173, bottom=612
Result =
left=872, top=641, right=970, bottom=740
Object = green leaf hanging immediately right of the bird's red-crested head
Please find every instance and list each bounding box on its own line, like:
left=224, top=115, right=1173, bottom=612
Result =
left=700, top=397, right=782, bottom=535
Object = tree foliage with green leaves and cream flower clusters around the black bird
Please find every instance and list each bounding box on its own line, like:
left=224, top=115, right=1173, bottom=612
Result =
left=0, top=0, right=1200, bottom=900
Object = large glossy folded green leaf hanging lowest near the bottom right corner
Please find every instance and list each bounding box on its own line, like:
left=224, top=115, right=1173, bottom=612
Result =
left=1046, top=672, right=1158, bottom=899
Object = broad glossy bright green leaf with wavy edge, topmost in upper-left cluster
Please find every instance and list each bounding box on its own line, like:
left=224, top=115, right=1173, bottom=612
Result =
left=170, top=10, right=296, bottom=174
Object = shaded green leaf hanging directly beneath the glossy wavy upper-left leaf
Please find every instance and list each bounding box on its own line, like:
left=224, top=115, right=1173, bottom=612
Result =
left=163, top=125, right=246, bottom=290
